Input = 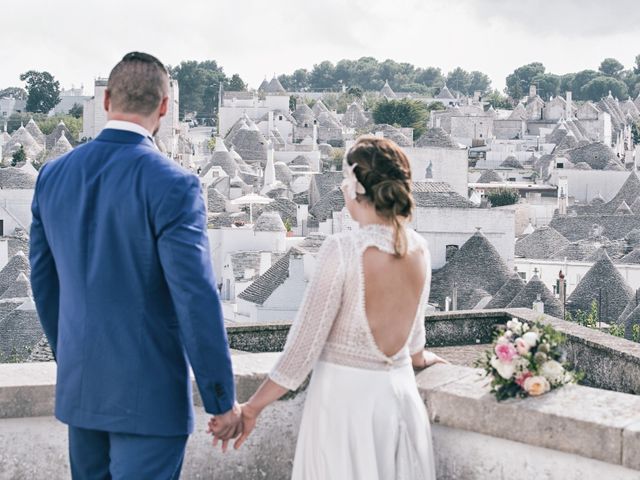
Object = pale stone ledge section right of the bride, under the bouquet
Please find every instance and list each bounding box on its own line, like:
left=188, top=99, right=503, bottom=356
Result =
left=417, top=365, right=640, bottom=470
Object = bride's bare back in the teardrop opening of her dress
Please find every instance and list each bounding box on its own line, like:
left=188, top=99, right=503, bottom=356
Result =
left=362, top=247, right=427, bottom=356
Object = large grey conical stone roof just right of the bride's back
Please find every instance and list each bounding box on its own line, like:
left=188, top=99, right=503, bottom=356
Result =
left=429, top=232, right=511, bottom=309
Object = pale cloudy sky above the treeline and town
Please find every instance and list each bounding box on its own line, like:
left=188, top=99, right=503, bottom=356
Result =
left=0, top=0, right=640, bottom=94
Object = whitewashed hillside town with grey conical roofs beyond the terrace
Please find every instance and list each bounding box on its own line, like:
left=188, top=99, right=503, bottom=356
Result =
left=0, top=60, right=640, bottom=362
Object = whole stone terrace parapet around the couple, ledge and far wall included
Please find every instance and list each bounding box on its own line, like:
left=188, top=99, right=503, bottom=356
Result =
left=0, top=309, right=640, bottom=480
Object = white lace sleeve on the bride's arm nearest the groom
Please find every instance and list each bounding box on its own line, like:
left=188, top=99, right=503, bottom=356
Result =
left=269, top=237, right=344, bottom=390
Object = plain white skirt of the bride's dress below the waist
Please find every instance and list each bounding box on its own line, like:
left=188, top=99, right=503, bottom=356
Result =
left=291, top=358, right=436, bottom=480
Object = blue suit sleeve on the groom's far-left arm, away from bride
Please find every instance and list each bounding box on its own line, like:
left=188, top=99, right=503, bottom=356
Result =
left=29, top=167, right=60, bottom=358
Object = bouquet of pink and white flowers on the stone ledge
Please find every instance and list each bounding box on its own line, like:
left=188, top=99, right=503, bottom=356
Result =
left=476, top=318, right=581, bottom=401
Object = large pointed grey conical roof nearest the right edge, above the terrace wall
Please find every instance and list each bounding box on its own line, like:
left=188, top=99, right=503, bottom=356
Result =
left=567, top=251, right=633, bottom=322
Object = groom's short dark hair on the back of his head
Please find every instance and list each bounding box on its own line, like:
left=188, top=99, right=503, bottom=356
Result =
left=107, top=52, right=169, bottom=116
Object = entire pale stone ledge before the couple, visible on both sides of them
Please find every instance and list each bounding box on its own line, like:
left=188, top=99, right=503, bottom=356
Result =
left=0, top=353, right=640, bottom=470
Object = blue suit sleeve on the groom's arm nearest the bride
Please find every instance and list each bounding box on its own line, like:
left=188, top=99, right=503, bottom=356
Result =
left=155, top=176, right=235, bottom=415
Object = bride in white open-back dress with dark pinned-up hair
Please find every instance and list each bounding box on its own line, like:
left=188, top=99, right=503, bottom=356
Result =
left=214, top=137, right=444, bottom=480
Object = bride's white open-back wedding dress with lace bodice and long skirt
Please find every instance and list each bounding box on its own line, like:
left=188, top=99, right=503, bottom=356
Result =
left=270, top=225, right=436, bottom=480
